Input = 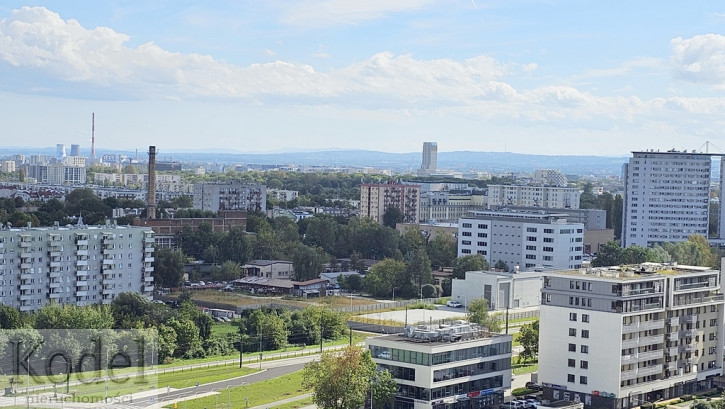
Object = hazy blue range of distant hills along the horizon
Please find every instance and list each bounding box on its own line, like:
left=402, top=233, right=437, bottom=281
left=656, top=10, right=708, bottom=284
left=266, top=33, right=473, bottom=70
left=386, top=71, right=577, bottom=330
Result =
left=0, top=147, right=628, bottom=175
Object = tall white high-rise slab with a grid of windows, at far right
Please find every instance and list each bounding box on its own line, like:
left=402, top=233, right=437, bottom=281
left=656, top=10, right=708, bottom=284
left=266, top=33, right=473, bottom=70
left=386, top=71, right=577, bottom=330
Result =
left=622, top=151, right=708, bottom=247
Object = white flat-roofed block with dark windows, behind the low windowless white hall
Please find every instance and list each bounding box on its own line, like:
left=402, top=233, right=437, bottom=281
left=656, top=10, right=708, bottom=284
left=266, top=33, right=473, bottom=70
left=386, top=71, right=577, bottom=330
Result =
left=458, top=210, right=584, bottom=270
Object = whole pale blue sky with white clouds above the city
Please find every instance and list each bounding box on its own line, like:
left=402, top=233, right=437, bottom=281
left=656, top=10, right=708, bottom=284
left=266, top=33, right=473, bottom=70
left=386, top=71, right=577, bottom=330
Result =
left=0, top=0, right=725, bottom=156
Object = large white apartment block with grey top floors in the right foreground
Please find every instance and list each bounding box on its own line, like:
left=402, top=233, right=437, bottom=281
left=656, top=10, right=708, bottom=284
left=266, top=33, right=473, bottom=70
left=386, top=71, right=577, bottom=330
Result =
left=538, top=263, right=724, bottom=409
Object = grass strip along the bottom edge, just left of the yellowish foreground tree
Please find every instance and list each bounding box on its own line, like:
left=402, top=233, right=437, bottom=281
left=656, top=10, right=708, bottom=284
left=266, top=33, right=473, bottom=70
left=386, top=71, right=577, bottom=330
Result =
left=165, top=371, right=309, bottom=409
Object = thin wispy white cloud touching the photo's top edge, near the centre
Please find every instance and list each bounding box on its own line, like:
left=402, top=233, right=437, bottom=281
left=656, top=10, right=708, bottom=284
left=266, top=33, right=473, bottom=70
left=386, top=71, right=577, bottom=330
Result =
left=281, top=0, right=433, bottom=28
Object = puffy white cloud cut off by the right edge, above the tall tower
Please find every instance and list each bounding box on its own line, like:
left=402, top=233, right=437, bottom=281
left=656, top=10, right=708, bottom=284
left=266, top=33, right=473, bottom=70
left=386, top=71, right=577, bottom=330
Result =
left=671, top=34, right=725, bottom=89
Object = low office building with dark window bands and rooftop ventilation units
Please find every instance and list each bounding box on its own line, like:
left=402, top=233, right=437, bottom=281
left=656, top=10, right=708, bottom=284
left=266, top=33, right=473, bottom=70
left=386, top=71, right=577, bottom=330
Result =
left=365, top=321, right=513, bottom=409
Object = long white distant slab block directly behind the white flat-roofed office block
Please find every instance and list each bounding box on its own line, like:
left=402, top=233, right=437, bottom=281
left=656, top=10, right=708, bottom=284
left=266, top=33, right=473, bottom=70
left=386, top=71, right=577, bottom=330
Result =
left=488, top=185, right=581, bottom=209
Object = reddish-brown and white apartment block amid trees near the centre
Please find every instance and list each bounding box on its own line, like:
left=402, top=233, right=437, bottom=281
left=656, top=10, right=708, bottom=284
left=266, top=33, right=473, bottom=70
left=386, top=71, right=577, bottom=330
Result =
left=360, top=183, right=420, bottom=223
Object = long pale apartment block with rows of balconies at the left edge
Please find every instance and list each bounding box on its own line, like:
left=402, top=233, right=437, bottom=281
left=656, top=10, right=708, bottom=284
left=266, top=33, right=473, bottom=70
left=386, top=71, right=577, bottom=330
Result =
left=0, top=225, right=154, bottom=311
